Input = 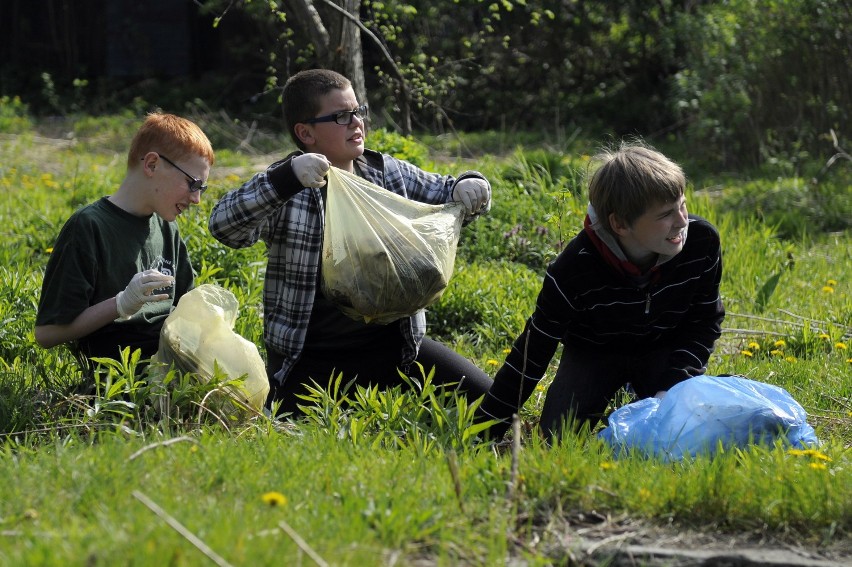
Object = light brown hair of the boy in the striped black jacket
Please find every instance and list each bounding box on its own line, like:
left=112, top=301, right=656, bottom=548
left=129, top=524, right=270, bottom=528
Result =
left=589, top=142, right=686, bottom=233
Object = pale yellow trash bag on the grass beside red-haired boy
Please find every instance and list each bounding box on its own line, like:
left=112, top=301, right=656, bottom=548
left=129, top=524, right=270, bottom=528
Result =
left=156, top=284, right=269, bottom=411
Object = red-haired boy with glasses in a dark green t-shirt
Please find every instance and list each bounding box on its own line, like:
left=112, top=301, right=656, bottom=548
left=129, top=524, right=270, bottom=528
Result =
left=35, top=113, right=214, bottom=363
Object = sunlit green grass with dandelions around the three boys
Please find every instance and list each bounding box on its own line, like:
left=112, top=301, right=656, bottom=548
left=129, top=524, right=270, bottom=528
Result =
left=0, top=108, right=852, bottom=565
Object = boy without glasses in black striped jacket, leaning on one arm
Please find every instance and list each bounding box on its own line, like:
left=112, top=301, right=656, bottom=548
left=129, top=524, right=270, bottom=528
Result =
left=478, top=143, right=725, bottom=440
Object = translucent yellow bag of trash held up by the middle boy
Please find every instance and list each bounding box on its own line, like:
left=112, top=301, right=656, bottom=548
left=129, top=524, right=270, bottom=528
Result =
left=322, top=167, right=464, bottom=323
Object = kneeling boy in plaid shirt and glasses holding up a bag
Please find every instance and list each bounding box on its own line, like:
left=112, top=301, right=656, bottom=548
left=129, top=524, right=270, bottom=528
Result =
left=209, top=69, right=491, bottom=414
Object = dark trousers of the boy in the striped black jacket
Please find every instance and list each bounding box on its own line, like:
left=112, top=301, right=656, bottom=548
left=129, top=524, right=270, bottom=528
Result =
left=539, top=348, right=671, bottom=440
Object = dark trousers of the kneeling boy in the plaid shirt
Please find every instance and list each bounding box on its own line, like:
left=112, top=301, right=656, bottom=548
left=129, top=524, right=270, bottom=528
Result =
left=266, top=337, right=492, bottom=416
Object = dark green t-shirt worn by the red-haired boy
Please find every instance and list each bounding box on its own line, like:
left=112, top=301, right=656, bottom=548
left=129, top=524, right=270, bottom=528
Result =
left=36, top=197, right=195, bottom=358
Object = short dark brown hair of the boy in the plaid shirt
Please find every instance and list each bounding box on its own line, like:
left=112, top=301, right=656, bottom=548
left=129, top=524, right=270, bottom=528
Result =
left=281, top=69, right=352, bottom=150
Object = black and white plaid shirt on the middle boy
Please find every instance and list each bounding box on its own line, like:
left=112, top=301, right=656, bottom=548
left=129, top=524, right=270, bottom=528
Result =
left=208, top=150, right=490, bottom=380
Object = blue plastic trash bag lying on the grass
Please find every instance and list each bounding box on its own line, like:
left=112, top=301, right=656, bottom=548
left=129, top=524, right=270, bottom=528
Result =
left=598, top=375, right=819, bottom=461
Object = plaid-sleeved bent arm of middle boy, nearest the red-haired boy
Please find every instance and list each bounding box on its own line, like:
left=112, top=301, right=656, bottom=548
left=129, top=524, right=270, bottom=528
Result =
left=207, top=152, right=304, bottom=248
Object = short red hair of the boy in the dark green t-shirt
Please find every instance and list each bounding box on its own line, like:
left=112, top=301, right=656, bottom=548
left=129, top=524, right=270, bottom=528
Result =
left=127, top=111, right=215, bottom=168
